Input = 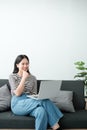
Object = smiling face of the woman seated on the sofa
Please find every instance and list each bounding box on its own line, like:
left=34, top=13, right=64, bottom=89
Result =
left=17, top=58, right=29, bottom=72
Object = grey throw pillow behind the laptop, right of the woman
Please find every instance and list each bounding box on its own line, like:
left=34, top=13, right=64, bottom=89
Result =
left=51, top=90, right=75, bottom=112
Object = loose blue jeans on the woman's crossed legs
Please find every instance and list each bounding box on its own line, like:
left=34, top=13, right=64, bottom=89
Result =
left=11, top=94, right=63, bottom=130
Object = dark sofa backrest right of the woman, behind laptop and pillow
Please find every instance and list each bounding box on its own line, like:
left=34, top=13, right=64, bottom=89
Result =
left=37, top=80, right=85, bottom=110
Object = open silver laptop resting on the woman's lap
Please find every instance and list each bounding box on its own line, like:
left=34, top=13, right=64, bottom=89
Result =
left=28, top=80, right=61, bottom=100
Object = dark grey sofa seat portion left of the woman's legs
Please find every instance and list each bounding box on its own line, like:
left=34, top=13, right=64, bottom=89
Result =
left=0, top=111, right=35, bottom=129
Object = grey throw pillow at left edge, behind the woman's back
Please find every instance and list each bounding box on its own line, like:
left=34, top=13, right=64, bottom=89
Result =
left=0, top=84, right=11, bottom=111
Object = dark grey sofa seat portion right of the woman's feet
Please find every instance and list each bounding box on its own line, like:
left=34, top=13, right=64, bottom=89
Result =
left=60, top=110, right=87, bottom=129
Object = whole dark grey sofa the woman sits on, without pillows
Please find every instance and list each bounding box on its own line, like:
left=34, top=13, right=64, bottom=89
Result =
left=0, top=79, right=87, bottom=129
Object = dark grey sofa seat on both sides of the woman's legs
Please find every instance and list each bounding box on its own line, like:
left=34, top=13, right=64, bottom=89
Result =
left=0, top=110, right=87, bottom=129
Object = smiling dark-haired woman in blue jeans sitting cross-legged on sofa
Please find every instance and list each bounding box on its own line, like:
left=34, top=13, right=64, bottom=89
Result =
left=9, top=55, right=63, bottom=130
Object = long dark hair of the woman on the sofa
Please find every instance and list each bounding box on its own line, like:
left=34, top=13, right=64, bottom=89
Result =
left=13, top=55, right=30, bottom=73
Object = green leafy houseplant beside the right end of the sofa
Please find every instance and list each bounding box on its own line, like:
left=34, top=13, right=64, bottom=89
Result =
left=74, top=61, right=87, bottom=97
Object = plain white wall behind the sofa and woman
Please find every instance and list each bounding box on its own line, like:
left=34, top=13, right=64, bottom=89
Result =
left=0, top=0, right=87, bottom=80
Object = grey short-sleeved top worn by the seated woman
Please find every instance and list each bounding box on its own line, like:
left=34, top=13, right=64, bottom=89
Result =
left=9, top=73, right=37, bottom=95
